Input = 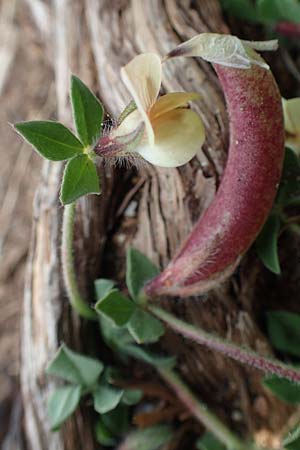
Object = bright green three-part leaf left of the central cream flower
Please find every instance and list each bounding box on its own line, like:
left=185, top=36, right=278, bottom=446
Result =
left=15, top=76, right=103, bottom=205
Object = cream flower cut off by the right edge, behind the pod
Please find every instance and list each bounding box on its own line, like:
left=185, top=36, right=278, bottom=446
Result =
left=282, top=97, right=300, bottom=156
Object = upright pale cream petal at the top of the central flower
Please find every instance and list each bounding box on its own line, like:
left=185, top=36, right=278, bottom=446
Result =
left=121, top=53, right=161, bottom=143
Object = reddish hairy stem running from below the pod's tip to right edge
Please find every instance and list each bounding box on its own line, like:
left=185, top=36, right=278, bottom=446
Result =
left=148, top=305, right=300, bottom=384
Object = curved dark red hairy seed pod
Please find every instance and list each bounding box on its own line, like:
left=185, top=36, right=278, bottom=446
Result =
left=145, top=42, right=284, bottom=297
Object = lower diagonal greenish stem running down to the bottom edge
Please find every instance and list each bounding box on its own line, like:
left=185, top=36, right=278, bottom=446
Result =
left=157, top=368, right=247, bottom=450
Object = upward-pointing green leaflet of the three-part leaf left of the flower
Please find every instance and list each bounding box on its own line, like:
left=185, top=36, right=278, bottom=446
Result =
left=71, top=75, right=103, bottom=147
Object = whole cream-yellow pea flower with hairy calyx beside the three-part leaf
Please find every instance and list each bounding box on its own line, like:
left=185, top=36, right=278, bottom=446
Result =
left=95, top=53, right=205, bottom=167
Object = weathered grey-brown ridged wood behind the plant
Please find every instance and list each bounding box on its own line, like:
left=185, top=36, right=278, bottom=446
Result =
left=21, top=0, right=300, bottom=450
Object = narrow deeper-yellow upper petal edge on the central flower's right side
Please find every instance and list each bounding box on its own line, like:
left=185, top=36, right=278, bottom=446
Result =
left=150, top=92, right=200, bottom=121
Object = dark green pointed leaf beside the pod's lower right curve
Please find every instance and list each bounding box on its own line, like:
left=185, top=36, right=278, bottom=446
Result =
left=255, top=214, right=281, bottom=275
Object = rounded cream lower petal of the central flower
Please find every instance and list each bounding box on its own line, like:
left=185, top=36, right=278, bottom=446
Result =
left=139, top=109, right=205, bottom=167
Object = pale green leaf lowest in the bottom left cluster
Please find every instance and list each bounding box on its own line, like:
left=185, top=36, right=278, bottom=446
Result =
left=47, top=385, right=81, bottom=431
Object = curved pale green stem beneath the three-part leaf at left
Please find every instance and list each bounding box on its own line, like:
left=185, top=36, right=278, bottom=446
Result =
left=61, top=203, right=97, bottom=320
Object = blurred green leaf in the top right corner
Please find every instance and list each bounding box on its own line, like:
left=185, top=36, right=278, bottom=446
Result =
left=257, top=0, right=300, bottom=24
